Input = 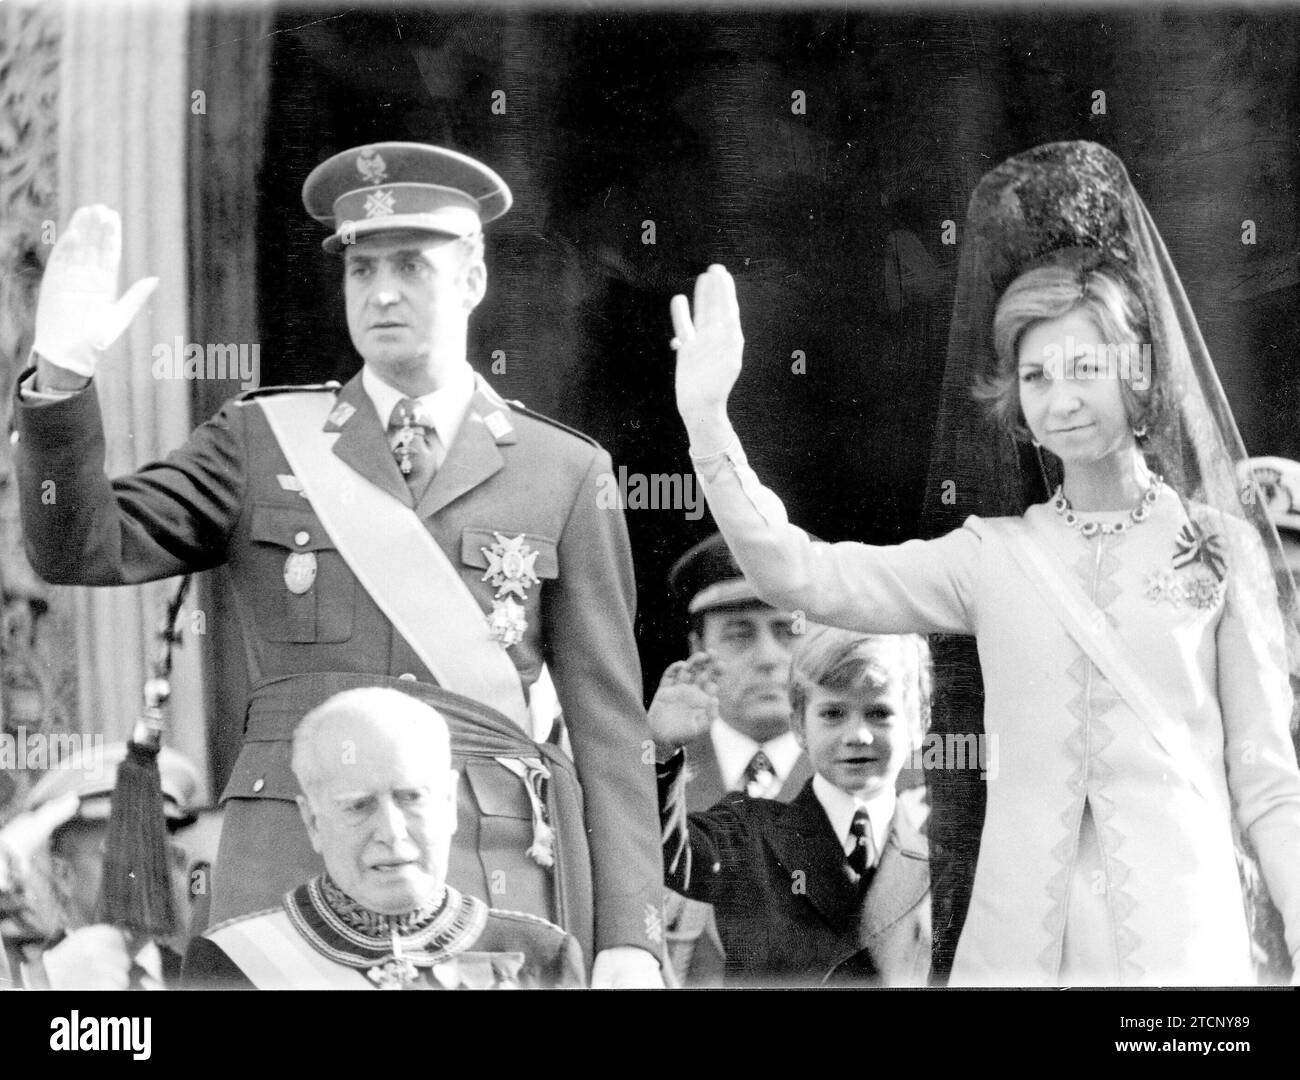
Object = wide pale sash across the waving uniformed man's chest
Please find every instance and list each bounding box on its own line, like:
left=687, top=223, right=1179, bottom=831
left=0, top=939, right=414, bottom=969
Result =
left=257, top=392, right=530, bottom=730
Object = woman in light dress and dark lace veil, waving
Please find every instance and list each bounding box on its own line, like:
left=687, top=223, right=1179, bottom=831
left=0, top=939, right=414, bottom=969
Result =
left=672, top=143, right=1300, bottom=985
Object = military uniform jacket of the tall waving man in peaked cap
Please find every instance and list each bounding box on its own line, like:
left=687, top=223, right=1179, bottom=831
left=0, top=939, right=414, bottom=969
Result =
left=17, top=366, right=663, bottom=953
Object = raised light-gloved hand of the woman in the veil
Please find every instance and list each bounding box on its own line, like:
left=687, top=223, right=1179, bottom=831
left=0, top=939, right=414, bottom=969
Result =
left=670, top=264, right=745, bottom=447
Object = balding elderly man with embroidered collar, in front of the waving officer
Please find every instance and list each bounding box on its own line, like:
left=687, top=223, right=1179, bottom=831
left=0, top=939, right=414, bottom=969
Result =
left=186, top=688, right=584, bottom=989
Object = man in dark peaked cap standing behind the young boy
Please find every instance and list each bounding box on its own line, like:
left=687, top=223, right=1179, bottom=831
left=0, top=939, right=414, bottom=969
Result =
left=650, top=533, right=813, bottom=986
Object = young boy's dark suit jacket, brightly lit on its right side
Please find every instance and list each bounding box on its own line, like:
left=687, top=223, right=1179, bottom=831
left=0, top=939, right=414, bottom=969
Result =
left=659, top=759, right=930, bottom=985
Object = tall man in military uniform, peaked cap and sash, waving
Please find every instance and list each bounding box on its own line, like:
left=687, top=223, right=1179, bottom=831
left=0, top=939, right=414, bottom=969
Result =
left=17, top=143, right=662, bottom=986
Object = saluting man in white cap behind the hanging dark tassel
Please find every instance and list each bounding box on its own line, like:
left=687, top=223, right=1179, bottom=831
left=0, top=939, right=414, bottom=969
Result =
left=0, top=742, right=198, bottom=989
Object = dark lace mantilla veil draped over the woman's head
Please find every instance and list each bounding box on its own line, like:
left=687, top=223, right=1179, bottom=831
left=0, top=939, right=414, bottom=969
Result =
left=922, top=142, right=1300, bottom=980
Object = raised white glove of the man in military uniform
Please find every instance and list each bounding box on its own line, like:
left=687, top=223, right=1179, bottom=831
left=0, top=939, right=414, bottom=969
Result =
left=33, top=205, right=159, bottom=378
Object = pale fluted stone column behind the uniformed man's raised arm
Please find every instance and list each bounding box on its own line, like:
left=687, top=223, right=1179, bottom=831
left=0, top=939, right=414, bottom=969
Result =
left=59, top=0, right=207, bottom=795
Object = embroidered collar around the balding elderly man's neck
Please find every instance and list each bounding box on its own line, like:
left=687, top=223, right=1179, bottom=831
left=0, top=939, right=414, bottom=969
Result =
left=285, top=873, right=489, bottom=971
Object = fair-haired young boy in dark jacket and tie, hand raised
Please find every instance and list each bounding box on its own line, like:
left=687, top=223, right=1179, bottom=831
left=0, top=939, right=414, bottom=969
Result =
left=650, top=626, right=931, bottom=985
